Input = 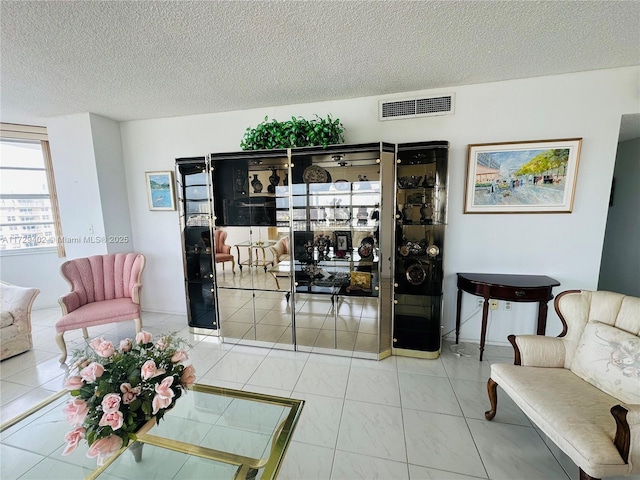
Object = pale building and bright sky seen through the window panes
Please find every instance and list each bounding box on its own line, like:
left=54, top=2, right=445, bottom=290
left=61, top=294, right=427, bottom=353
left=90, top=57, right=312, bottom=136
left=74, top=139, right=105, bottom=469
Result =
left=0, top=138, right=57, bottom=252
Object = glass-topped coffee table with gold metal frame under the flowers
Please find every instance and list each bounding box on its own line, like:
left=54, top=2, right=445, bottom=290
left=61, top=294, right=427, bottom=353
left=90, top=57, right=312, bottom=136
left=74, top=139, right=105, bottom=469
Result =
left=0, top=384, right=304, bottom=480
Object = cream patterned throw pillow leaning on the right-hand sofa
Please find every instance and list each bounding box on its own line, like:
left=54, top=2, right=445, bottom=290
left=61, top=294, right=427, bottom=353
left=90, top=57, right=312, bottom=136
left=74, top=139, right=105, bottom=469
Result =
left=571, top=321, right=640, bottom=404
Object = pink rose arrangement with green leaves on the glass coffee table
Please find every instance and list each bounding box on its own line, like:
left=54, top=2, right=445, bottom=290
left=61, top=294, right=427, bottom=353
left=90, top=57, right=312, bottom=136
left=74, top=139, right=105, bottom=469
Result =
left=62, top=331, right=195, bottom=465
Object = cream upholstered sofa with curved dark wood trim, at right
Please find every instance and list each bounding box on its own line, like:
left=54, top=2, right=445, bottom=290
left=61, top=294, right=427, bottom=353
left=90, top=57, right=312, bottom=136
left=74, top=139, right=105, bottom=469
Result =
left=485, top=290, right=640, bottom=479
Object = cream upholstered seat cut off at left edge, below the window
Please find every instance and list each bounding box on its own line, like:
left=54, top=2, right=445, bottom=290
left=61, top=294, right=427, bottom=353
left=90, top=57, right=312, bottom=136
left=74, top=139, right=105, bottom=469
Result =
left=0, top=282, right=40, bottom=360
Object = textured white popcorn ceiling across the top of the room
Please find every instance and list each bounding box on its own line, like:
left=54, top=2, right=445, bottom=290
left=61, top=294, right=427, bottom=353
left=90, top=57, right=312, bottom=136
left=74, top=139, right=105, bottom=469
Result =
left=0, top=0, right=640, bottom=133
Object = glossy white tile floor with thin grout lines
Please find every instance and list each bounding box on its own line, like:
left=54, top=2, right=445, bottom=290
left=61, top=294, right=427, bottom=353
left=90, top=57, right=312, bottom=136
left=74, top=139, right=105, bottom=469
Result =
left=0, top=308, right=624, bottom=480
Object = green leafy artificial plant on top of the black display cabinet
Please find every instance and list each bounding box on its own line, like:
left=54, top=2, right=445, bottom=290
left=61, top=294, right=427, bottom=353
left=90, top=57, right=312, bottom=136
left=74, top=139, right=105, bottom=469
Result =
left=240, top=115, right=344, bottom=150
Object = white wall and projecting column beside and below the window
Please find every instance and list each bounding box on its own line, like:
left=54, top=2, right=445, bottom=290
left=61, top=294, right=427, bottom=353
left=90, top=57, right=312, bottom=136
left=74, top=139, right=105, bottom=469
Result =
left=0, top=113, right=134, bottom=308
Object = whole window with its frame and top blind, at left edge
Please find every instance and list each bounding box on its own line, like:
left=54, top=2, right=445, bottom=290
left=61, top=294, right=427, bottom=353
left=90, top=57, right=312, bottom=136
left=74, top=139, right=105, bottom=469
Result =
left=0, top=123, right=64, bottom=257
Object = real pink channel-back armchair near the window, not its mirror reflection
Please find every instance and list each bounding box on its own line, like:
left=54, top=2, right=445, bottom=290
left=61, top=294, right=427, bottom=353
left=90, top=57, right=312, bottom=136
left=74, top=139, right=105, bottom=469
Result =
left=56, top=253, right=145, bottom=363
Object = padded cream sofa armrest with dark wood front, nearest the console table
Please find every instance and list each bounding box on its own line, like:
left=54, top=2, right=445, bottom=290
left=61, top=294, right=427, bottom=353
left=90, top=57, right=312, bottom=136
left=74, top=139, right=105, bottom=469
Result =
left=508, top=335, right=566, bottom=368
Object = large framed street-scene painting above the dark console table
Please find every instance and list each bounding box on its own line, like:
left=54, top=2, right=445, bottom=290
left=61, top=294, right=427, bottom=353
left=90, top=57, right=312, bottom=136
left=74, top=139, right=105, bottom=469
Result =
left=464, top=138, right=582, bottom=213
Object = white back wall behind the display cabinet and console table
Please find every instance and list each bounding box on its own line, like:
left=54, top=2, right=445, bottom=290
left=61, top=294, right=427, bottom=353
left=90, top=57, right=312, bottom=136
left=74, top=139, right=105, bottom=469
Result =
left=120, top=67, right=640, bottom=343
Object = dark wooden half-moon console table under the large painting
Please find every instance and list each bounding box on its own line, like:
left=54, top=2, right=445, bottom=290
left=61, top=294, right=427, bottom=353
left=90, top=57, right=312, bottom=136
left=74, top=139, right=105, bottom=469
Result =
left=456, top=273, right=560, bottom=360
